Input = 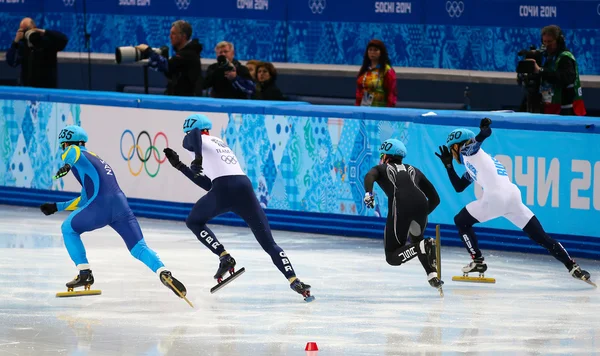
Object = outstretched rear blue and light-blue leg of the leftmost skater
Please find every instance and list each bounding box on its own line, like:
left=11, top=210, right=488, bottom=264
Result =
left=110, top=212, right=164, bottom=272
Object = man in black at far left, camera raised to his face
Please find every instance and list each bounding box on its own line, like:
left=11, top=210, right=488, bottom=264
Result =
left=6, top=17, right=69, bottom=88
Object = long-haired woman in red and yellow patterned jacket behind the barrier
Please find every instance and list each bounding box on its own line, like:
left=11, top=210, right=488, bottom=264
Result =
left=356, top=40, right=398, bottom=107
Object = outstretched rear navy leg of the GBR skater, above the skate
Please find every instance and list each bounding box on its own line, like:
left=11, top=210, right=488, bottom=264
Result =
left=234, top=191, right=296, bottom=282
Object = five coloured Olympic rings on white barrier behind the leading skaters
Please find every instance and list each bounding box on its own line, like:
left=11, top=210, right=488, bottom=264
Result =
left=120, top=130, right=169, bottom=178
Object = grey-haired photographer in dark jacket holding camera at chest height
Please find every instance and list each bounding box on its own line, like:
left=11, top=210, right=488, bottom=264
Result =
left=204, top=41, right=255, bottom=99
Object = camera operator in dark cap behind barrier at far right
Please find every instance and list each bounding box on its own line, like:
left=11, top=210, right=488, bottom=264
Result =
left=526, top=25, right=586, bottom=116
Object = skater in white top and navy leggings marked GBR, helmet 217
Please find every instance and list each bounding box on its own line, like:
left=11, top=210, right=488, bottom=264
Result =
left=164, top=114, right=314, bottom=301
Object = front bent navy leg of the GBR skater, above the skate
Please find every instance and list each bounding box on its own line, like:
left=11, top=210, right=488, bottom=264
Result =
left=185, top=190, right=227, bottom=256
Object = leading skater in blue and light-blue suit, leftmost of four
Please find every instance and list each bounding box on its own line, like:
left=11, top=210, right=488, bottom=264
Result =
left=40, top=125, right=186, bottom=296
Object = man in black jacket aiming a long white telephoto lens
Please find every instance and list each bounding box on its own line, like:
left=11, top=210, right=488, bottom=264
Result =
left=136, top=20, right=202, bottom=96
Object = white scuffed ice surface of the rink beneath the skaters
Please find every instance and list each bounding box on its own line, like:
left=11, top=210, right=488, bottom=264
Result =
left=0, top=206, right=600, bottom=356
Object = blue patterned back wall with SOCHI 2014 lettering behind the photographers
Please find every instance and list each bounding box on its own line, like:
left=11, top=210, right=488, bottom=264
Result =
left=0, top=0, right=600, bottom=74
